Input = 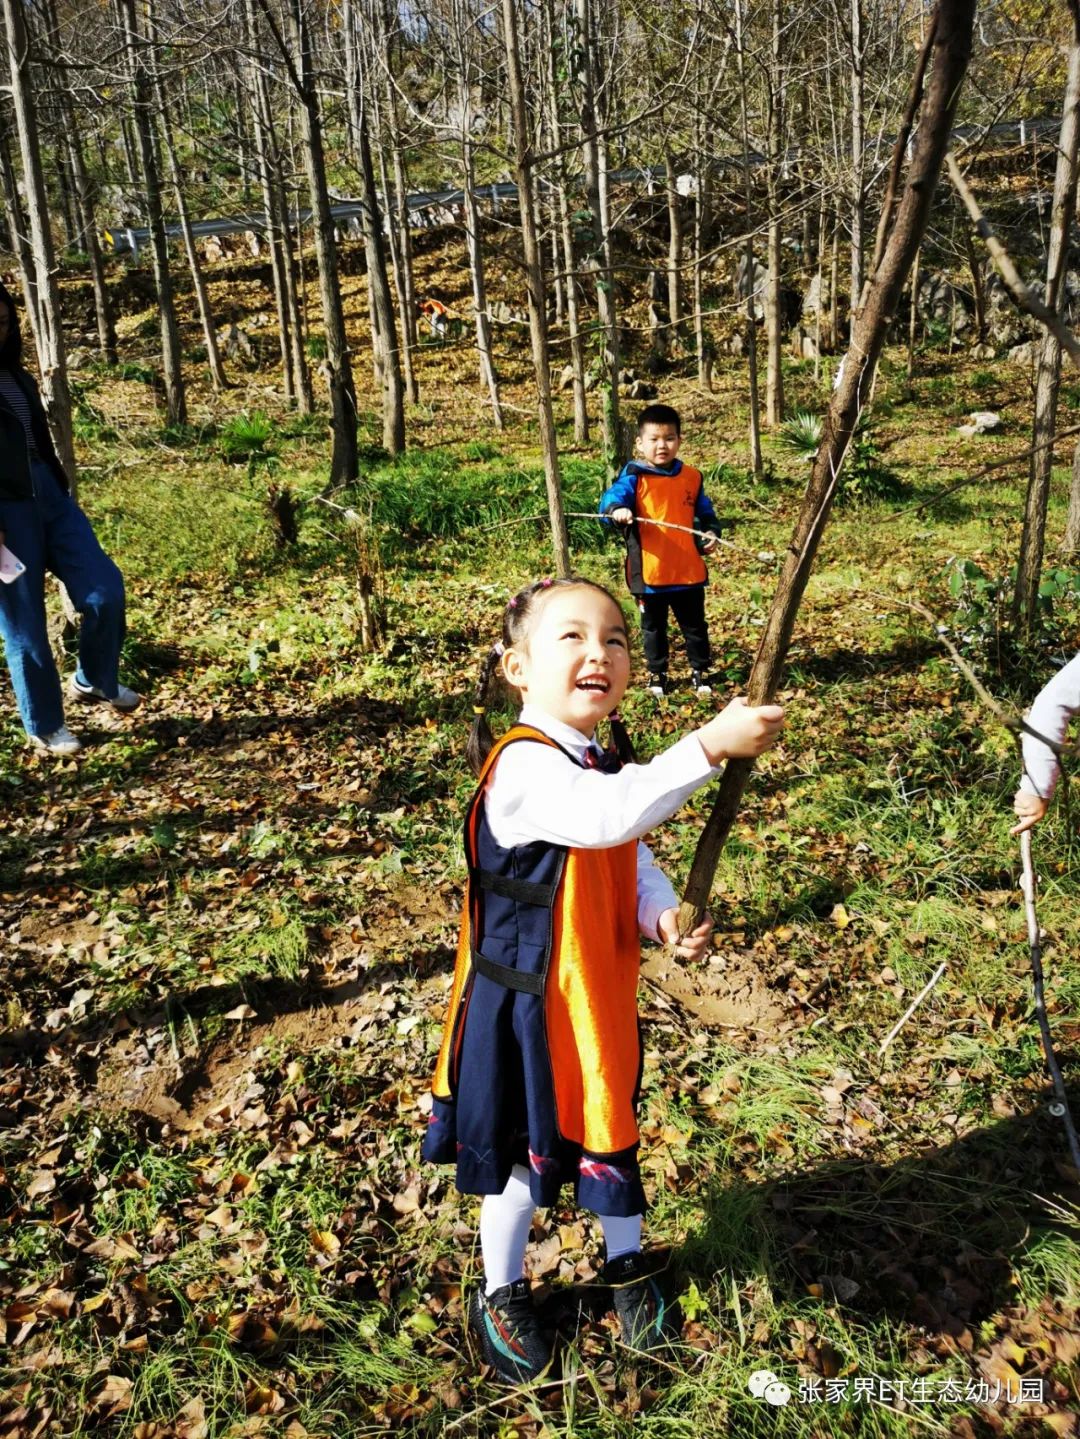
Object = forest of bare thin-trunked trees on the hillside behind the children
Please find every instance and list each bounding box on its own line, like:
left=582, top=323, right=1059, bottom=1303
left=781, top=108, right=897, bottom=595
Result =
left=0, top=0, right=1080, bottom=616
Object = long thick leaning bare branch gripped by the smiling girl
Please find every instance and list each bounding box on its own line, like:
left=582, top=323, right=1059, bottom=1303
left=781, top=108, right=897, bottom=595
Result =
left=679, top=0, right=975, bottom=934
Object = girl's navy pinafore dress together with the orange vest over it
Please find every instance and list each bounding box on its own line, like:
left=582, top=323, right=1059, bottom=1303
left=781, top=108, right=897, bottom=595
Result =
left=423, top=725, right=644, bottom=1215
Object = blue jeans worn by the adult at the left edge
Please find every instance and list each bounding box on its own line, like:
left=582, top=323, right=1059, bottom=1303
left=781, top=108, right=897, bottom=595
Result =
left=0, top=460, right=125, bottom=735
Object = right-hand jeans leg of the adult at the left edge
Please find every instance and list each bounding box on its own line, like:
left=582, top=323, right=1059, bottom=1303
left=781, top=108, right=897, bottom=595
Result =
left=35, top=465, right=127, bottom=699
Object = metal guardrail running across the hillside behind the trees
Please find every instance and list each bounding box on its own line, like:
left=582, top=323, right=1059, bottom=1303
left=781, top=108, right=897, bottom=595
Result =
left=102, top=118, right=1061, bottom=259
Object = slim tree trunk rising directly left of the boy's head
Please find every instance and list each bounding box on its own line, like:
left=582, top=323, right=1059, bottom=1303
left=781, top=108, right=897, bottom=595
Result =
left=574, top=0, right=621, bottom=469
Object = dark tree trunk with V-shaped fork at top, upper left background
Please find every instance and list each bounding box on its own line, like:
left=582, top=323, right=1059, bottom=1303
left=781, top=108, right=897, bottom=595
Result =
left=257, top=0, right=360, bottom=485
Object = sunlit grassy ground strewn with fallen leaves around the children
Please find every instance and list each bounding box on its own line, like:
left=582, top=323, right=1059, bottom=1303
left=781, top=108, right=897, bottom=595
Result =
left=0, top=241, right=1080, bottom=1439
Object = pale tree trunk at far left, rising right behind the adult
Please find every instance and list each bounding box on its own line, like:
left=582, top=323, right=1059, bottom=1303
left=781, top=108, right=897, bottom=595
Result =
left=3, top=0, right=76, bottom=471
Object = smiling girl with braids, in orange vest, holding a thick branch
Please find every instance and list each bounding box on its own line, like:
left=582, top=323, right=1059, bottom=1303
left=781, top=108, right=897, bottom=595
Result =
left=424, top=578, right=784, bottom=1383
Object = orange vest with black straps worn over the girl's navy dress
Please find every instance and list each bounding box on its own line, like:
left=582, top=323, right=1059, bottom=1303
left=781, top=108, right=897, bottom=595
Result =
left=431, top=725, right=641, bottom=1156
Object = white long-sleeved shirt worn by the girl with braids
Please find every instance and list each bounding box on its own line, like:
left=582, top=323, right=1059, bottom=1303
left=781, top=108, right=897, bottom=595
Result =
left=485, top=705, right=719, bottom=940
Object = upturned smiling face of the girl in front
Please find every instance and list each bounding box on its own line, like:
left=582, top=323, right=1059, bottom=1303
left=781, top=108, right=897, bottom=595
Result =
left=502, top=586, right=630, bottom=737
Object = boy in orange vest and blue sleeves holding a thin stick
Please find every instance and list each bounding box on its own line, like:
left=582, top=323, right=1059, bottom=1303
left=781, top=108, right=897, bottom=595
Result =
left=600, top=404, right=722, bottom=695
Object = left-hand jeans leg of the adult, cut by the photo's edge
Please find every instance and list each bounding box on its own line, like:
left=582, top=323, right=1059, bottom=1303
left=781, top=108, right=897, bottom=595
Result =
left=0, top=499, right=63, bottom=735
